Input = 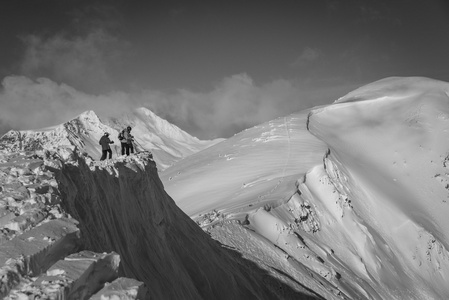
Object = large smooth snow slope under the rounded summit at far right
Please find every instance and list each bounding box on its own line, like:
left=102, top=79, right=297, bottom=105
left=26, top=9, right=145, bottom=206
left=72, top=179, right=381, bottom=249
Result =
left=306, top=78, right=449, bottom=299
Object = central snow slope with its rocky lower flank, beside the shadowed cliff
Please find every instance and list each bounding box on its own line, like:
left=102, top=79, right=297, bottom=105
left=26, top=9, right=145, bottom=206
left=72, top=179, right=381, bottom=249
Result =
left=161, top=111, right=350, bottom=299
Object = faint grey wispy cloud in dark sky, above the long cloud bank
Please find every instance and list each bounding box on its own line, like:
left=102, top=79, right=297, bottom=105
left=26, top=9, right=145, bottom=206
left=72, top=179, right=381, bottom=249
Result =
left=20, top=28, right=127, bottom=92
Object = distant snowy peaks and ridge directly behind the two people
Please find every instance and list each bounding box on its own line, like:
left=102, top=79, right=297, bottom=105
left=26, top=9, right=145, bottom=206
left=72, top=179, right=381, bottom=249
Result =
left=0, top=108, right=220, bottom=170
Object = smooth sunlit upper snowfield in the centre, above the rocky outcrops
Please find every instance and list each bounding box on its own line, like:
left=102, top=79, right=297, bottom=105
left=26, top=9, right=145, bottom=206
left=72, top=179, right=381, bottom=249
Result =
left=161, top=111, right=327, bottom=217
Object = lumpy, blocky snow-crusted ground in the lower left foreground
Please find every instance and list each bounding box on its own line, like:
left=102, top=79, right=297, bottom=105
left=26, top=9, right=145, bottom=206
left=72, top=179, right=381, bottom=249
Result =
left=0, top=148, right=135, bottom=299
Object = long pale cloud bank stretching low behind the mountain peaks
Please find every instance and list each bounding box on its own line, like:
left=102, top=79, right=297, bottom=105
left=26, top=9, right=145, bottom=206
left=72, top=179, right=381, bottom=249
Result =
left=0, top=74, right=352, bottom=139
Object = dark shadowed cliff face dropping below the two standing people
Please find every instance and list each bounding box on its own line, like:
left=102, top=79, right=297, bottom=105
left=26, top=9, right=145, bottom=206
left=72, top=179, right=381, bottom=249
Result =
left=53, top=153, right=313, bottom=299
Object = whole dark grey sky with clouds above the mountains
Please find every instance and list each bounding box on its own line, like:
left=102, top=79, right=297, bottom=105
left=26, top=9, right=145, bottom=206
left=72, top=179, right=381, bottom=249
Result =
left=0, top=0, right=449, bottom=139
